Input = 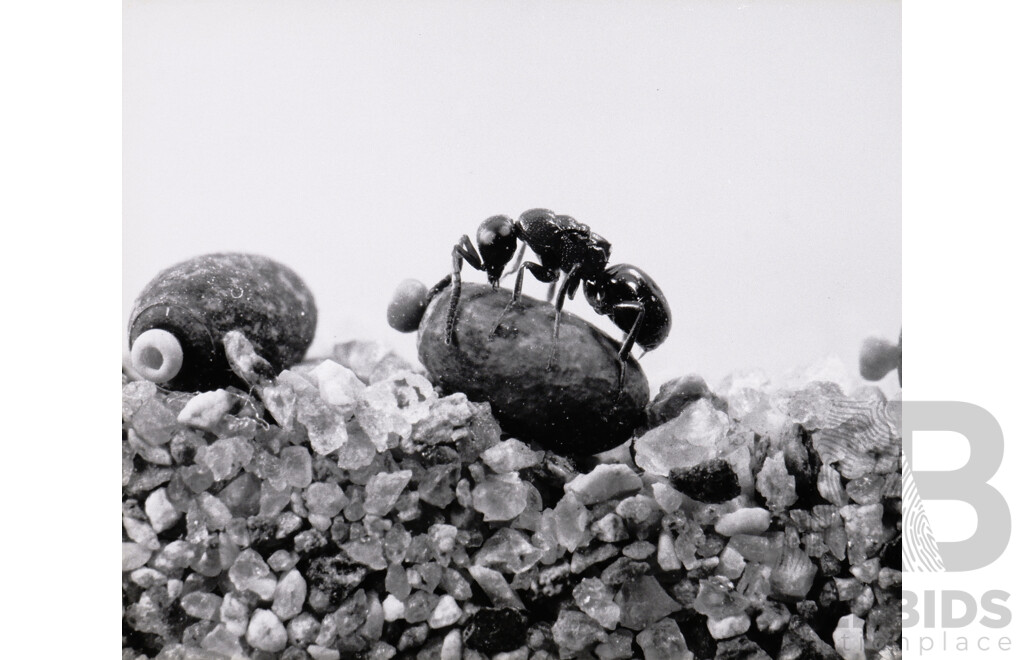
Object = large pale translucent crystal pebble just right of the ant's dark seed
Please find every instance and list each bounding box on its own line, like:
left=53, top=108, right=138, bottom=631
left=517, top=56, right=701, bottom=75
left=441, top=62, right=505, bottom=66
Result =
left=634, top=399, right=730, bottom=477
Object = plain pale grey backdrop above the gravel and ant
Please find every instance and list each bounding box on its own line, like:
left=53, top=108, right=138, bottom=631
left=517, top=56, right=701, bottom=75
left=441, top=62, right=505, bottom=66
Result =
left=123, top=0, right=900, bottom=386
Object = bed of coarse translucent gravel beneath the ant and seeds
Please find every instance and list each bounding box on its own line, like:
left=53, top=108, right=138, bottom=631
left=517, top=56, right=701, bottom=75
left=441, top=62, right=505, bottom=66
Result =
left=122, top=337, right=901, bottom=660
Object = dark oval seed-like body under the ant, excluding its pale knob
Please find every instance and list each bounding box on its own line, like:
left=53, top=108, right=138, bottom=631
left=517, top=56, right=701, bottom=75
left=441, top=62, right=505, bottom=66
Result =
left=418, top=283, right=650, bottom=454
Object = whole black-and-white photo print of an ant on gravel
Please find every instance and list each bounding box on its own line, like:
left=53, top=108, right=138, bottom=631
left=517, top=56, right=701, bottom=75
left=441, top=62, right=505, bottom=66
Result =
left=116, top=0, right=909, bottom=660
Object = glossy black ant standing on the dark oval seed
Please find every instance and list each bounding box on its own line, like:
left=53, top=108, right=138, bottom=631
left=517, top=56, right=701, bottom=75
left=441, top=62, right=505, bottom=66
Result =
left=431, top=209, right=672, bottom=377
